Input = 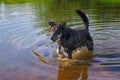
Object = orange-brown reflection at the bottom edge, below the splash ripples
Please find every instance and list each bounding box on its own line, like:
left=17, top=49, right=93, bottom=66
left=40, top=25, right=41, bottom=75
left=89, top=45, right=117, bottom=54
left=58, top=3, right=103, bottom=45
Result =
left=57, top=64, right=90, bottom=80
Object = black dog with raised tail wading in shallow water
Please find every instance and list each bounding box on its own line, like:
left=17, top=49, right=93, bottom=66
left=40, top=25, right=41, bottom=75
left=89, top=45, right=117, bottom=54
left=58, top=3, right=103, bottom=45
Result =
left=48, top=10, right=93, bottom=59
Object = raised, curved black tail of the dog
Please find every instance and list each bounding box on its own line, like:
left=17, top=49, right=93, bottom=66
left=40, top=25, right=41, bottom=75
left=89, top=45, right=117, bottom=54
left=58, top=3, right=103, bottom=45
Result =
left=76, top=10, right=89, bottom=31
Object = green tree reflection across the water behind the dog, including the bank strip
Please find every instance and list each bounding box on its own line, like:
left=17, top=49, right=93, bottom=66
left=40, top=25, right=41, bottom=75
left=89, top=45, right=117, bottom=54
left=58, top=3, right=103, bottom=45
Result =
left=0, top=0, right=120, bottom=30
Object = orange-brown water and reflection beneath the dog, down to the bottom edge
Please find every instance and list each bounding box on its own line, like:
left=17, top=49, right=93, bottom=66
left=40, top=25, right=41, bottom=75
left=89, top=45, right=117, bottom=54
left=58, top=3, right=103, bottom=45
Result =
left=57, top=50, right=93, bottom=80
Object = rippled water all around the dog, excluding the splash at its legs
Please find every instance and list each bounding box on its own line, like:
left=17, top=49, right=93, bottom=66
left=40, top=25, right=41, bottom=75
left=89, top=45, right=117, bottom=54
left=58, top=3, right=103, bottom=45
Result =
left=0, top=0, right=120, bottom=80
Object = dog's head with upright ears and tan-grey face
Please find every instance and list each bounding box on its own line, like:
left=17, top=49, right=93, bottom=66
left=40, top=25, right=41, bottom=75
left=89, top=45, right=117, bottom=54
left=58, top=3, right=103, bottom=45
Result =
left=48, top=22, right=66, bottom=41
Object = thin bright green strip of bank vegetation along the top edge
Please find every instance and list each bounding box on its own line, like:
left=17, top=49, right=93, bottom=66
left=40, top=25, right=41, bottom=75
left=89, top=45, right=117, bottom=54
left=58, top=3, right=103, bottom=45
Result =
left=0, top=0, right=120, bottom=4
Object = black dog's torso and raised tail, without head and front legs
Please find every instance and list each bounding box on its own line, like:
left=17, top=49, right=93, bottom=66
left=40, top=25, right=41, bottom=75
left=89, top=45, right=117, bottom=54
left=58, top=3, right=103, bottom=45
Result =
left=60, top=10, right=93, bottom=50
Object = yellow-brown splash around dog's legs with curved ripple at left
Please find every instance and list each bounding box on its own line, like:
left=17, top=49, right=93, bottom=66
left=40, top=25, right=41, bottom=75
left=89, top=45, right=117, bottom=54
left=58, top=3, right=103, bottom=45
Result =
left=32, top=49, right=94, bottom=67
